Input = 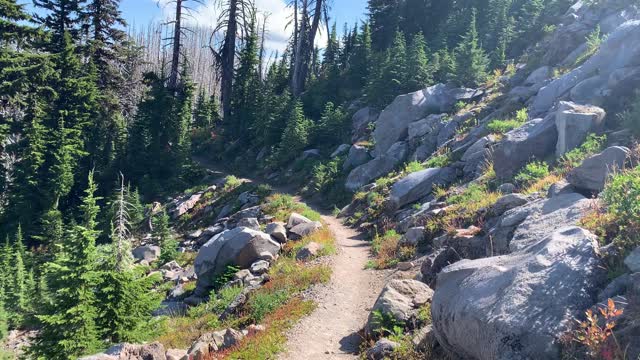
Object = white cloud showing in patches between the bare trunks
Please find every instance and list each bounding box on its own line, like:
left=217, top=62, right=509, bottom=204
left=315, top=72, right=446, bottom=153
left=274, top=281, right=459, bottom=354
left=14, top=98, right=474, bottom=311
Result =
left=156, top=0, right=327, bottom=53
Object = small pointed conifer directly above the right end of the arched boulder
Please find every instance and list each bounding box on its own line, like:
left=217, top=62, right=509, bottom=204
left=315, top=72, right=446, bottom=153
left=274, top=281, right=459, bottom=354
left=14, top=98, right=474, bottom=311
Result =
left=456, top=10, right=489, bottom=86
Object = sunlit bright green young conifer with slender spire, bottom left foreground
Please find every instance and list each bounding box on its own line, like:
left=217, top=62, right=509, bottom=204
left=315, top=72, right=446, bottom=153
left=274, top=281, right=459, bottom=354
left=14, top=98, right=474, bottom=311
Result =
left=30, top=173, right=100, bottom=360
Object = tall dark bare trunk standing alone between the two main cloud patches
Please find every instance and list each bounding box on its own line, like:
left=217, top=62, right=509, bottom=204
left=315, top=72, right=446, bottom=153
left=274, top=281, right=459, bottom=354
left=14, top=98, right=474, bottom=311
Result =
left=220, top=0, right=238, bottom=120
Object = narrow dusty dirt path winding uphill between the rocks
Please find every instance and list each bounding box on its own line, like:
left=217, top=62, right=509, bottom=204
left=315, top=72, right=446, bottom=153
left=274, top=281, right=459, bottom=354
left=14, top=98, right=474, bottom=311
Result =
left=195, top=158, right=384, bottom=360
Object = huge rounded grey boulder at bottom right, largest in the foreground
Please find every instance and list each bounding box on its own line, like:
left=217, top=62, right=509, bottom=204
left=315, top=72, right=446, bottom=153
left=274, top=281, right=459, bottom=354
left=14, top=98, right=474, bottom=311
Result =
left=431, top=227, right=602, bottom=360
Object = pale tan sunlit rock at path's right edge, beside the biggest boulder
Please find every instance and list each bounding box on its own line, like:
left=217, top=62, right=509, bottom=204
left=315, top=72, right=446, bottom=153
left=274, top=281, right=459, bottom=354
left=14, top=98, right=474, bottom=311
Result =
left=365, top=280, right=433, bottom=335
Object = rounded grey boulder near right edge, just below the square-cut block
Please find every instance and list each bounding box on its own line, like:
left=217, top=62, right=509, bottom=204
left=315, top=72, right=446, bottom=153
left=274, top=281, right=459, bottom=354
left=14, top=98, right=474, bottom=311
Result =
left=567, top=146, right=630, bottom=192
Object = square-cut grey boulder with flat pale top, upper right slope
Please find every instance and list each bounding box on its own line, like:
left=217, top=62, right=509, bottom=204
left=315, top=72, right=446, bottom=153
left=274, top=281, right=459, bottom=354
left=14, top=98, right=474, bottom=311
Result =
left=556, top=101, right=606, bottom=157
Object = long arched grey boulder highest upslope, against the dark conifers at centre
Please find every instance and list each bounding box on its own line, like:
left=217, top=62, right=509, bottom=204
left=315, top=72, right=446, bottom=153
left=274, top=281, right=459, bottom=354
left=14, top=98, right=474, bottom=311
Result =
left=373, top=84, right=480, bottom=157
